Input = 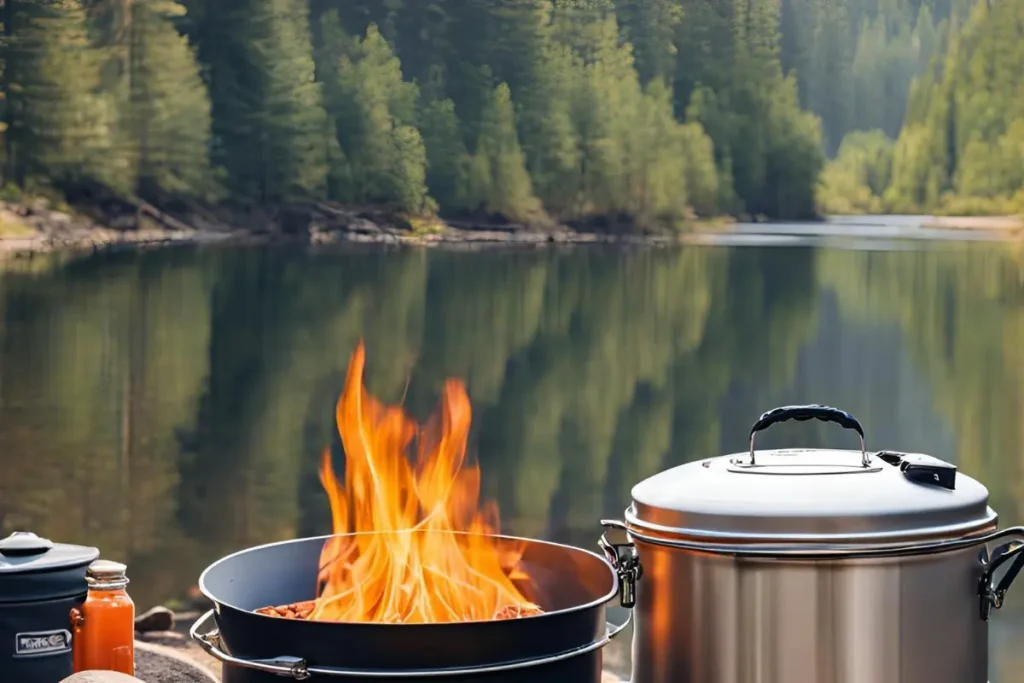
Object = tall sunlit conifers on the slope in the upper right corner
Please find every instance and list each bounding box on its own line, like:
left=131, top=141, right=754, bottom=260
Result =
left=885, top=0, right=1024, bottom=213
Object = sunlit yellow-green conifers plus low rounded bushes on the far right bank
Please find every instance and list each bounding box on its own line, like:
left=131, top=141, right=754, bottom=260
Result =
left=822, top=0, right=1024, bottom=214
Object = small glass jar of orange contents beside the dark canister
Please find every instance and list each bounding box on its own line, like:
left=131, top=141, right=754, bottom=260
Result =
left=72, top=560, right=135, bottom=676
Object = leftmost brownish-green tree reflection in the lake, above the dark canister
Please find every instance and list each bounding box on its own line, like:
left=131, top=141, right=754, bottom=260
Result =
left=0, top=253, right=210, bottom=594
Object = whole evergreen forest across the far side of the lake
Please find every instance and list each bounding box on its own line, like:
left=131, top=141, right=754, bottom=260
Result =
left=0, top=0, right=1024, bottom=230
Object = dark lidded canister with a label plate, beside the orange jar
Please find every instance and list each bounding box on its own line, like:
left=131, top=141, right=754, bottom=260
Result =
left=0, top=531, right=99, bottom=683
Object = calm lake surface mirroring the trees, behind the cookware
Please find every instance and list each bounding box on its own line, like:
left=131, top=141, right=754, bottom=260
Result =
left=0, top=241, right=1024, bottom=683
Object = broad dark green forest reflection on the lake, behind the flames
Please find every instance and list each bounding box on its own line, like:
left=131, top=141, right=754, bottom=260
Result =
left=0, top=242, right=815, bottom=604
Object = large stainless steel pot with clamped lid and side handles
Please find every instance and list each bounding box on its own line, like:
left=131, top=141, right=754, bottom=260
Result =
left=601, top=405, right=1024, bottom=683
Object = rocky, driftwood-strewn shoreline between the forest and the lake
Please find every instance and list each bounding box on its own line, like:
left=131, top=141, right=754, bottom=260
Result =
left=0, top=200, right=1024, bottom=259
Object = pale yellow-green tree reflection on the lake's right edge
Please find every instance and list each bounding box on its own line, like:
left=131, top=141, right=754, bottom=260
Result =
left=820, top=247, right=1024, bottom=522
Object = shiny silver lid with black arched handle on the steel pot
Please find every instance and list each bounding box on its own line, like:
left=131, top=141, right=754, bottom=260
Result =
left=626, top=404, right=997, bottom=544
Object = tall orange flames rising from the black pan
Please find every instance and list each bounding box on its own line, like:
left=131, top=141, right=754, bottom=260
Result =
left=309, top=341, right=537, bottom=624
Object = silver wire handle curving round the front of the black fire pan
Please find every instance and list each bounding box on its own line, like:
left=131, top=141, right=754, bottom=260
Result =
left=188, top=609, right=633, bottom=681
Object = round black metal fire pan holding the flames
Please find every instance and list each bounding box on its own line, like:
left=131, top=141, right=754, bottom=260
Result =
left=191, top=537, right=622, bottom=683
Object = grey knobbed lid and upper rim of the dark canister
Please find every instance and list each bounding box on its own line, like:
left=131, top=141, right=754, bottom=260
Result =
left=0, top=531, right=99, bottom=602
